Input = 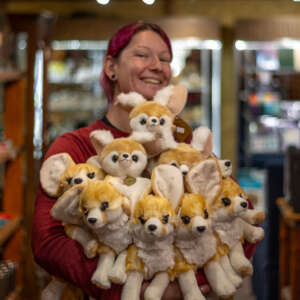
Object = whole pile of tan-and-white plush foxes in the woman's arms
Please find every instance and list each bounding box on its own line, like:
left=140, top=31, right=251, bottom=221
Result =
left=40, top=86, right=264, bottom=300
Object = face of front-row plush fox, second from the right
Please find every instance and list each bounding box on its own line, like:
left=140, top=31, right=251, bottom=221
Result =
left=176, top=194, right=210, bottom=238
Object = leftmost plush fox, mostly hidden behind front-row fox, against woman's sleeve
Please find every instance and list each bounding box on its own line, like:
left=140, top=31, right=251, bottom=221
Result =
left=40, top=153, right=104, bottom=300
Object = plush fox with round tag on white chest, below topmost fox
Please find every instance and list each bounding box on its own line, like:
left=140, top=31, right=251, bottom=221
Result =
left=90, top=130, right=151, bottom=211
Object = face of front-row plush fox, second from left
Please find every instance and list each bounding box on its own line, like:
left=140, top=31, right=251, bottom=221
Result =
left=131, top=195, right=175, bottom=240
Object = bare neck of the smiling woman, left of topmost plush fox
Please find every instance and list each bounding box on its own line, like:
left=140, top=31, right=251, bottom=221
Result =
left=106, top=104, right=131, bottom=133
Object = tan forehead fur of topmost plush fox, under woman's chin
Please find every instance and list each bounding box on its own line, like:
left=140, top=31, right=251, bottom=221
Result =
left=129, top=101, right=175, bottom=120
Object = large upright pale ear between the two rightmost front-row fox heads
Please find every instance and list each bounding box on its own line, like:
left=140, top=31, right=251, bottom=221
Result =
left=185, top=159, right=222, bottom=205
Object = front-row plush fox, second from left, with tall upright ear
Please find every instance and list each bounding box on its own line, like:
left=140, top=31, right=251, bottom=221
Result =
left=121, top=165, right=183, bottom=300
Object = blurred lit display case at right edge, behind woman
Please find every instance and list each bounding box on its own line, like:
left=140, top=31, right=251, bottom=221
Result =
left=234, top=17, right=300, bottom=300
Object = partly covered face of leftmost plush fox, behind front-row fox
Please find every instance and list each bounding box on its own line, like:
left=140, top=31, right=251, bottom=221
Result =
left=60, top=164, right=104, bottom=192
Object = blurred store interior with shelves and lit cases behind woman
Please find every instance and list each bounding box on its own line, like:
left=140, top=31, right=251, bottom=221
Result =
left=0, top=0, right=300, bottom=300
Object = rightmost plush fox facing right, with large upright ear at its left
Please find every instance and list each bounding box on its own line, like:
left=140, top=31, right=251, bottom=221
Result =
left=186, top=160, right=264, bottom=284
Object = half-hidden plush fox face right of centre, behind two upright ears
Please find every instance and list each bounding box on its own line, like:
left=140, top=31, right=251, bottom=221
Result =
left=158, top=143, right=206, bottom=175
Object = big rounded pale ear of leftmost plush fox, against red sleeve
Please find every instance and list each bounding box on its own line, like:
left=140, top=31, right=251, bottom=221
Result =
left=40, top=153, right=75, bottom=197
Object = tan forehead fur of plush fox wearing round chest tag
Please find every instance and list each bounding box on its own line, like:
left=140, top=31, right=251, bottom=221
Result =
left=100, top=138, right=146, bottom=162
